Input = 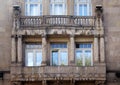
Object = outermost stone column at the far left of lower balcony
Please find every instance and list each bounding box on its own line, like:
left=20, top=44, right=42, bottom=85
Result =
left=11, top=35, right=16, bottom=63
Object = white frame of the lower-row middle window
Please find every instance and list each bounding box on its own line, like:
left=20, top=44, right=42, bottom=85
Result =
left=50, top=43, right=68, bottom=66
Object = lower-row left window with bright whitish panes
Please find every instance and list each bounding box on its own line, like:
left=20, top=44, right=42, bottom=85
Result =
left=25, top=44, right=42, bottom=66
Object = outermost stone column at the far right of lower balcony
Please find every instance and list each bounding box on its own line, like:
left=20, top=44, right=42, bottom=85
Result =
left=100, top=36, right=105, bottom=63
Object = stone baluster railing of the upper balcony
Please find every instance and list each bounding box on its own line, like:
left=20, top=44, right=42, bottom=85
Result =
left=20, top=15, right=95, bottom=28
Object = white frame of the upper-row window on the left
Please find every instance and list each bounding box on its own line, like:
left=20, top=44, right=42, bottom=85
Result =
left=25, top=0, right=43, bottom=16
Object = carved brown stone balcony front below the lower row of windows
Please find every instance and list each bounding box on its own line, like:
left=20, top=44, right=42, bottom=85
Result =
left=11, top=65, right=106, bottom=81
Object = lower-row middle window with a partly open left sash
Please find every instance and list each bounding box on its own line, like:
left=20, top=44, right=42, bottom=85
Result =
left=51, top=43, right=68, bottom=66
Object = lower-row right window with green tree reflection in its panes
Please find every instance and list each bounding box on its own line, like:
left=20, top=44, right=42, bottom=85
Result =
left=75, top=43, right=93, bottom=66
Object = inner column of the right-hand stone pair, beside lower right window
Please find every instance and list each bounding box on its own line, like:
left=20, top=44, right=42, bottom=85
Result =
left=94, top=36, right=99, bottom=63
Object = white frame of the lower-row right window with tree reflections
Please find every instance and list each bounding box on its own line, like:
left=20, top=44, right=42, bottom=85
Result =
left=75, top=43, right=93, bottom=66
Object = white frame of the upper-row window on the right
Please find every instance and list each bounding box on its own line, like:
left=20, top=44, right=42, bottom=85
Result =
left=74, top=0, right=92, bottom=16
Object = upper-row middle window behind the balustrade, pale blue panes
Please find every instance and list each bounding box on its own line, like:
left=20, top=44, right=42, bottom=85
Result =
left=50, top=0, right=66, bottom=15
